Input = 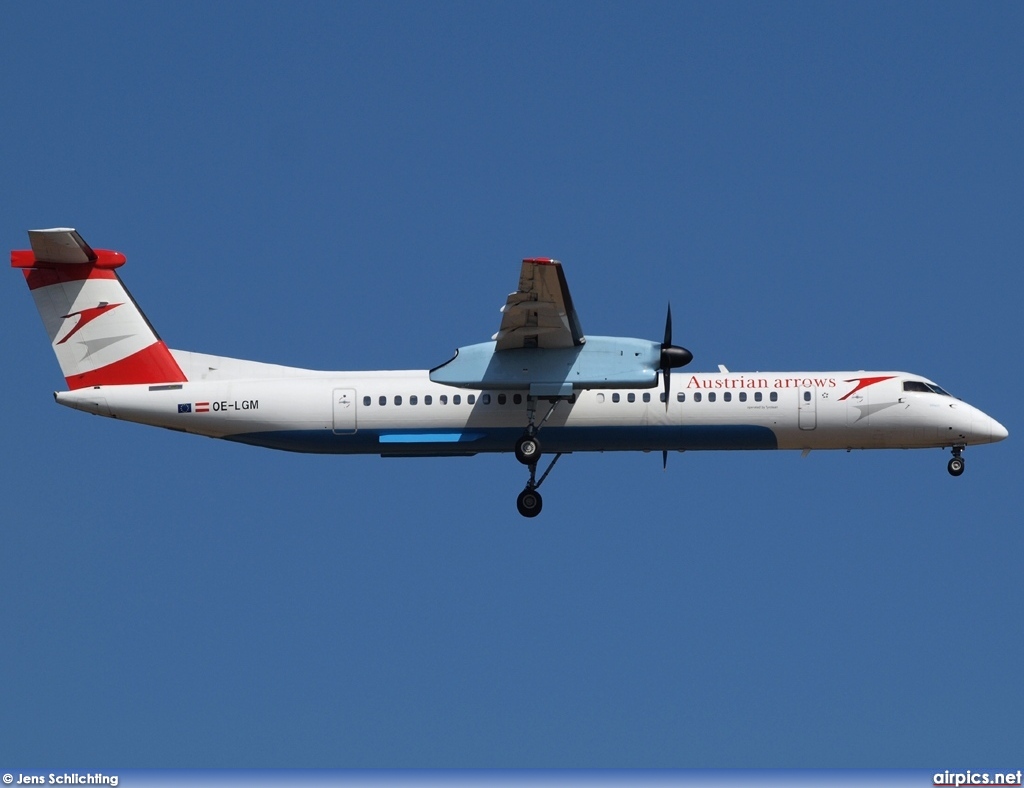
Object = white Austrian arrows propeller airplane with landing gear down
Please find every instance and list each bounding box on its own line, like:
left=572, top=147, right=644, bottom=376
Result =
left=11, top=227, right=1008, bottom=517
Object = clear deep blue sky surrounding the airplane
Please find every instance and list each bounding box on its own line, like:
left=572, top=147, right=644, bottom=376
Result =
left=0, top=2, right=1024, bottom=770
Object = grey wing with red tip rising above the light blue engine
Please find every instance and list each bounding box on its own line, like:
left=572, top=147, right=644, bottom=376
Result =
left=492, top=258, right=587, bottom=350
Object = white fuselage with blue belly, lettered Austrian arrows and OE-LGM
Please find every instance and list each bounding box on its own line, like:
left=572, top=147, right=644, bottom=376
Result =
left=55, top=351, right=1007, bottom=455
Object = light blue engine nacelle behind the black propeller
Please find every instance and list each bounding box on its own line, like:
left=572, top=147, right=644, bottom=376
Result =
left=430, top=337, right=662, bottom=396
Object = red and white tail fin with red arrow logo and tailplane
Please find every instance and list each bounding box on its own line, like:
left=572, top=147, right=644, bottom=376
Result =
left=10, top=227, right=186, bottom=389
